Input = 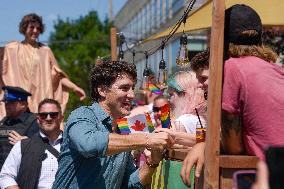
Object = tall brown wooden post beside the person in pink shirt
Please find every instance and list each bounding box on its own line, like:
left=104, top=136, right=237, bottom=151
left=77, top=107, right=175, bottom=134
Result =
left=204, top=0, right=225, bottom=189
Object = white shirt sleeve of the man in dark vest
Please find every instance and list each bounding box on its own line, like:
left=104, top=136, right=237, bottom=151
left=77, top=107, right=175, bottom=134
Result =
left=0, top=142, right=22, bottom=189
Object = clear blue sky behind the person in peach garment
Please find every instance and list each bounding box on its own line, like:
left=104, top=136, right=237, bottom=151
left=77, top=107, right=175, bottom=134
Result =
left=0, top=0, right=127, bottom=46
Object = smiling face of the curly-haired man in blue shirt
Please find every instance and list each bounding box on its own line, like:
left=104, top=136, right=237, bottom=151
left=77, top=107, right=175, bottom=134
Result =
left=100, top=74, right=135, bottom=119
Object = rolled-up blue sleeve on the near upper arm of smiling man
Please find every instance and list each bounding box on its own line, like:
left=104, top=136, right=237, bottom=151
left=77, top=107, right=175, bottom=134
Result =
left=66, top=108, right=109, bottom=157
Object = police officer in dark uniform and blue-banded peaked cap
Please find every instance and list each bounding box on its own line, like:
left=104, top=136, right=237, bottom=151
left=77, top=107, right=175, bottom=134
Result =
left=0, top=86, right=39, bottom=169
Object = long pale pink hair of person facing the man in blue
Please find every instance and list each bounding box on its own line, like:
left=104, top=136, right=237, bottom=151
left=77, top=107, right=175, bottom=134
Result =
left=172, top=71, right=206, bottom=118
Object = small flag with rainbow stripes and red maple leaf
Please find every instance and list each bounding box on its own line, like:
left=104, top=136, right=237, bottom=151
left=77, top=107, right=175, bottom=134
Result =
left=116, top=114, right=154, bottom=135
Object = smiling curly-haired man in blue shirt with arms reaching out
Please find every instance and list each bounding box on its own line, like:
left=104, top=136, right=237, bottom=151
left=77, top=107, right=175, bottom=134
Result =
left=53, top=61, right=174, bottom=189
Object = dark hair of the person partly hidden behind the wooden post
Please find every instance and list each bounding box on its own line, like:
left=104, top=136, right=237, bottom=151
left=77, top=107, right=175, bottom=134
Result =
left=191, top=48, right=210, bottom=72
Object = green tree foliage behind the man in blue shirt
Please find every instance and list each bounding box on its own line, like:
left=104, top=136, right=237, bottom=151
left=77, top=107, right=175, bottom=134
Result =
left=49, top=11, right=111, bottom=115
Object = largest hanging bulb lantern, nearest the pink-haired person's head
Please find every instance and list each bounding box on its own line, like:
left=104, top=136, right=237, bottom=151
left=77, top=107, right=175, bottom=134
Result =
left=176, top=33, right=189, bottom=66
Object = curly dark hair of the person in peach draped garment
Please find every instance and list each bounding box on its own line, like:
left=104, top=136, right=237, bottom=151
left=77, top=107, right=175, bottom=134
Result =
left=19, top=13, right=44, bottom=35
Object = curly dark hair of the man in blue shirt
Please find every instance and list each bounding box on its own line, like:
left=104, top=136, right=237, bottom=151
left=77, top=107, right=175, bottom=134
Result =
left=90, top=60, right=137, bottom=102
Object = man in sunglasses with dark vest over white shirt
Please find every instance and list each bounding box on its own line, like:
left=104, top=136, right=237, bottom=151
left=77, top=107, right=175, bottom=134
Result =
left=0, top=99, right=63, bottom=189
